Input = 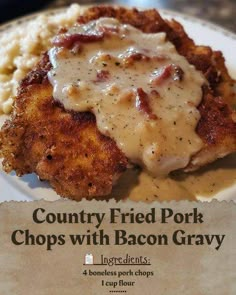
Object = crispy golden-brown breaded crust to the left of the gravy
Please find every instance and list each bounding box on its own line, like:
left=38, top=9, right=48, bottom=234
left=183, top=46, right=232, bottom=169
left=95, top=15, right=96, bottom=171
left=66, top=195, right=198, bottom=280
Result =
left=0, top=56, right=127, bottom=200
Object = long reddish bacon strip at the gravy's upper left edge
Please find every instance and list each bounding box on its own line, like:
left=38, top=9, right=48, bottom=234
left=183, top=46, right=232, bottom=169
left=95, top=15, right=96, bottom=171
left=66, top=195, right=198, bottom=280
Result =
left=52, top=33, right=104, bottom=49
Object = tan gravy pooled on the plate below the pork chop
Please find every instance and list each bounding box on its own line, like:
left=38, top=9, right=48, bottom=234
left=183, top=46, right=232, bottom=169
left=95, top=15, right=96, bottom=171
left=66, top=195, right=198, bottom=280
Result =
left=109, top=154, right=236, bottom=202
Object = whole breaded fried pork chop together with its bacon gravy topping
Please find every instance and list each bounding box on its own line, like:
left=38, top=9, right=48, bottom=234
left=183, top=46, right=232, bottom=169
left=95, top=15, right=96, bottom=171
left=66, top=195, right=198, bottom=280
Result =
left=0, top=6, right=236, bottom=200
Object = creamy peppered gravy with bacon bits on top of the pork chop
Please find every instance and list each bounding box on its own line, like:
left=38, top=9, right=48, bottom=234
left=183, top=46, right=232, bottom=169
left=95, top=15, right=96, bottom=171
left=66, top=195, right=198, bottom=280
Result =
left=48, top=18, right=206, bottom=176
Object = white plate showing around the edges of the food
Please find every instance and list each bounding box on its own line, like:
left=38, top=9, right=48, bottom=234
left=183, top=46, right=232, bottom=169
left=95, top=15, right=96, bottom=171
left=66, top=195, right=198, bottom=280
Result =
left=0, top=6, right=236, bottom=202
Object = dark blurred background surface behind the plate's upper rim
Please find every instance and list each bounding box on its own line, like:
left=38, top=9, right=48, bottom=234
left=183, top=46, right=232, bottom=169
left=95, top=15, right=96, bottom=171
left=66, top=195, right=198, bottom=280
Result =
left=0, top=0, right=236, bottom=32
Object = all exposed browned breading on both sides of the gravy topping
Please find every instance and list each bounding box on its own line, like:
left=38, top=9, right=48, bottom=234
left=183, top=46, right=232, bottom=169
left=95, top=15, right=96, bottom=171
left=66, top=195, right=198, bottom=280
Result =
left=0, top=6, right=236, bottom=200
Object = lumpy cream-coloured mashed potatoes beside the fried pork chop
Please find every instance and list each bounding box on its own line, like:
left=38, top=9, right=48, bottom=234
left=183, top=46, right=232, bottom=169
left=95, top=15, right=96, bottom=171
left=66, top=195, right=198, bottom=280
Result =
left=0, top=4, right=81, bottom=114
